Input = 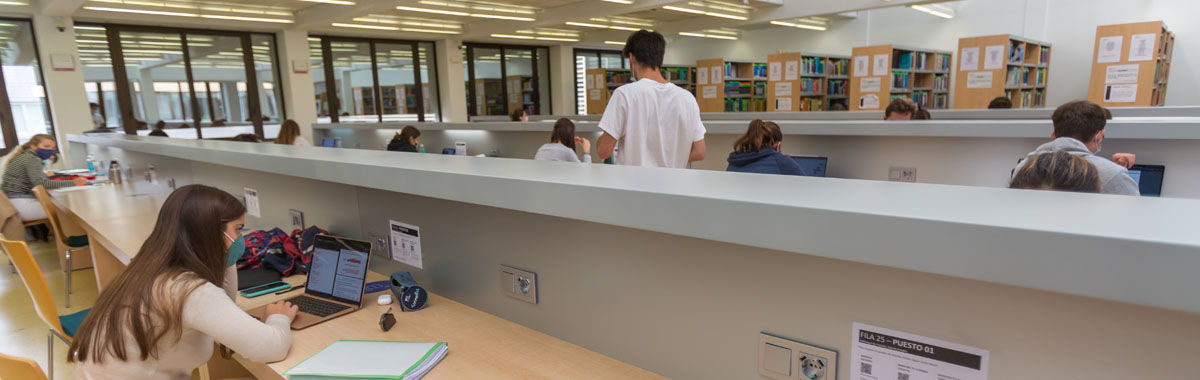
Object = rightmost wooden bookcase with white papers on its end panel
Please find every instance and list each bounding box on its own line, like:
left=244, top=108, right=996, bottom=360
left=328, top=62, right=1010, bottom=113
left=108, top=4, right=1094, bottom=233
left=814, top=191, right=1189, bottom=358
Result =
left=1087, top=22, right=1175, bottom=107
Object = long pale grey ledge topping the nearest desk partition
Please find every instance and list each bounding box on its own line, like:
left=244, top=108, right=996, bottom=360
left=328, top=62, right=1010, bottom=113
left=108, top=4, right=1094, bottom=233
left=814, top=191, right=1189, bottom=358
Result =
left=68, top=135, right=1200, bottom=313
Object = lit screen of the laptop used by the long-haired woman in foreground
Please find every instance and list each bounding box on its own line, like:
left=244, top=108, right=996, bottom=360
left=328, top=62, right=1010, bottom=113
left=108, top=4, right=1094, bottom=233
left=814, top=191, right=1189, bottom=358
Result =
left=305, top=235, right=371, bottom=304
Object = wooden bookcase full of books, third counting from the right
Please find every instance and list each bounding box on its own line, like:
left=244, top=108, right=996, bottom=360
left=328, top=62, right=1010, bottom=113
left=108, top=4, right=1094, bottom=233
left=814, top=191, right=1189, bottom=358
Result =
left=850, top=44, right=953, bottom=110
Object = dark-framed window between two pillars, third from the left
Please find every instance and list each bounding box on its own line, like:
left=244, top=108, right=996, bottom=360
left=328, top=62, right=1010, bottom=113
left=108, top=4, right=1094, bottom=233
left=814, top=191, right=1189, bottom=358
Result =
left=308, top=37, right=442, bottom=122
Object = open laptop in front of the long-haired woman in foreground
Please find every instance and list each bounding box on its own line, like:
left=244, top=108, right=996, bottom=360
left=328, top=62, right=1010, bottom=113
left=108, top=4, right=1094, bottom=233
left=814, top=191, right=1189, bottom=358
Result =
left=248, top=235, right=371, bottom=330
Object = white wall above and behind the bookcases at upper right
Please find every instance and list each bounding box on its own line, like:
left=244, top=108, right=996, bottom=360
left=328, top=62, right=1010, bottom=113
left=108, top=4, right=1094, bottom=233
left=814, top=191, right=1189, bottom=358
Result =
left=665, top=0, right=1200, bottom=107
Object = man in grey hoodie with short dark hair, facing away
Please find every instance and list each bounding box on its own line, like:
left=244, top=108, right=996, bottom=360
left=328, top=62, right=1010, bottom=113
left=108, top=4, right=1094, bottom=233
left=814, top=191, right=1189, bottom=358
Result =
left=1013, top=101, right=1141, bottom=195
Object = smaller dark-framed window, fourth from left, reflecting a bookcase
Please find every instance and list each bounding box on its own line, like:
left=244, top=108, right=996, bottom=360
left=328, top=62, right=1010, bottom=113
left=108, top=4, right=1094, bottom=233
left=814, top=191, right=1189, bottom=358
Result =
left=463, top=44, right=551, bottom=116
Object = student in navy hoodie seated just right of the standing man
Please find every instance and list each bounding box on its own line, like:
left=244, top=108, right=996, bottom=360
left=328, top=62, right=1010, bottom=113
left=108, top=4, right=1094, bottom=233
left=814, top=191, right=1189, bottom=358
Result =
left=725, top=119, right=805, bottom=175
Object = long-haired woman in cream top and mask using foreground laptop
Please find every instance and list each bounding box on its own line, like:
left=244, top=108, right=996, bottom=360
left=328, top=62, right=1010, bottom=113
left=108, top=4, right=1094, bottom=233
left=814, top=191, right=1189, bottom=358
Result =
left=67, top=185, right=296, bottom=380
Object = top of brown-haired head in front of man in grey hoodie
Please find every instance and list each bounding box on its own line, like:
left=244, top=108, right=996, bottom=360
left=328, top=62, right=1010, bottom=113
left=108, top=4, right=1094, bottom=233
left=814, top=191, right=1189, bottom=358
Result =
left=1008, top=151, right=1104, bottom=193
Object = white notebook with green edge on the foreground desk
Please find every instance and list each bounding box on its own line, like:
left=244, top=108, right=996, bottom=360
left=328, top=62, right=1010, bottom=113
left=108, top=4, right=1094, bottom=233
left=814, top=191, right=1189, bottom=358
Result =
left=283, top=339, right=449, bottom=380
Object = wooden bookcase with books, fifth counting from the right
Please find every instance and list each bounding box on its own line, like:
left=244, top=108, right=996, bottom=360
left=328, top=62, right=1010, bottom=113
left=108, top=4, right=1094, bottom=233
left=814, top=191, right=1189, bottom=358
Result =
left=696, top=59, right=767, bottom=113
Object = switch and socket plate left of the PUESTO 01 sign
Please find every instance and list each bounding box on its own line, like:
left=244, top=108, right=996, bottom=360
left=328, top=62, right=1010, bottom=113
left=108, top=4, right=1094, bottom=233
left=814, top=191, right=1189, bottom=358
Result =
left=758, top=332, right=838, bottom=380
